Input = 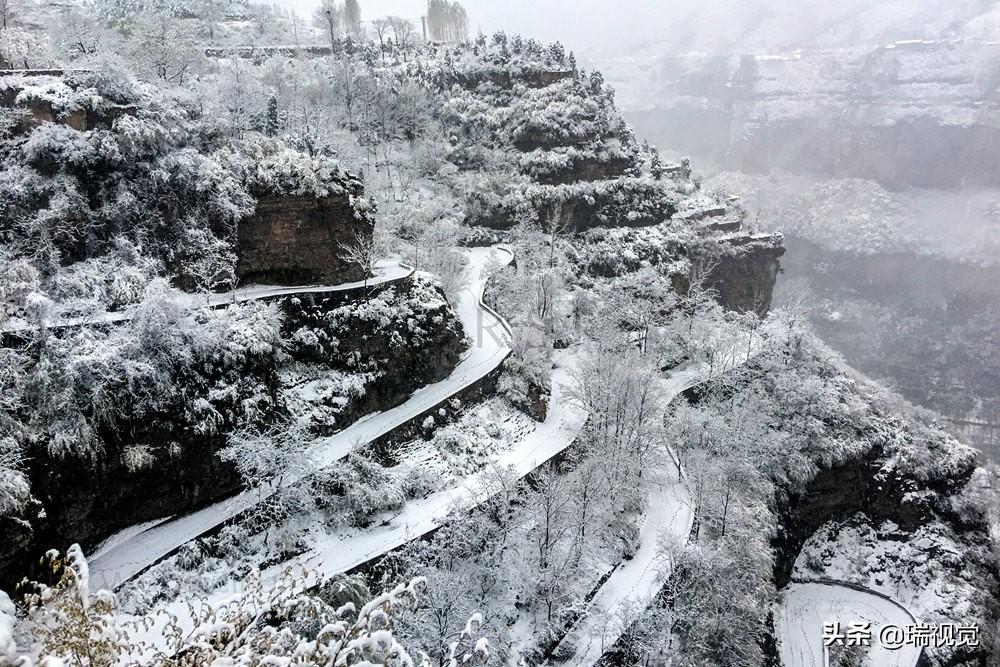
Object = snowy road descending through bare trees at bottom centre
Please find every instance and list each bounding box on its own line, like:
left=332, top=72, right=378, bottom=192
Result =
left=556, top=367, right=707, bottom=667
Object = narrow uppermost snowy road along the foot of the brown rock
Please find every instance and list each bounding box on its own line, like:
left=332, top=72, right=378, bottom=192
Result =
left=0, top=259, right=413, bottom=332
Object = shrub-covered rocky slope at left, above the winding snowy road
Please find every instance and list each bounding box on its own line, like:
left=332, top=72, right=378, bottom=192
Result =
left=0, top=71, right=464, bottom=580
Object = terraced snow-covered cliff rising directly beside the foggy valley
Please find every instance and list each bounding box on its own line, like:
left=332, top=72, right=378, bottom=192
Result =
left=431, top=47, right=784, bottom=314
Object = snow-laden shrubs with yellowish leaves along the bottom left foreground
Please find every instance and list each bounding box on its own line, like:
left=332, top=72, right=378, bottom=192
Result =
left=9, top=545, right=489, bottom=667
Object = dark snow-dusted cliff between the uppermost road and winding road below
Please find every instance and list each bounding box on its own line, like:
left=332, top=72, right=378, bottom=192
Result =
left=0, top=278, right=463, bottom=585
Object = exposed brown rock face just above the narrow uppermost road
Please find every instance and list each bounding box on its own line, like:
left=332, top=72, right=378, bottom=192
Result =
left=236, top=192, right=374, bottom=285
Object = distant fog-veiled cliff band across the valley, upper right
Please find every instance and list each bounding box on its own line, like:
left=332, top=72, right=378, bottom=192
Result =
left=601, top=39, right=1000, bottom=188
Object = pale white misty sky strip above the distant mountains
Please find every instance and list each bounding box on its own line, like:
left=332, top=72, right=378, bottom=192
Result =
left=275, top=0, right=1000, bottom=53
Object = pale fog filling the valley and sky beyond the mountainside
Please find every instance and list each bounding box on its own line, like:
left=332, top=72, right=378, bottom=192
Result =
left=270, top=0, right=1000, bottom=450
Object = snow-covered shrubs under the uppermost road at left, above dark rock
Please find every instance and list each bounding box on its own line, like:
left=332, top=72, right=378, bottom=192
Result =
left=9, top=280, right=282, bottom=458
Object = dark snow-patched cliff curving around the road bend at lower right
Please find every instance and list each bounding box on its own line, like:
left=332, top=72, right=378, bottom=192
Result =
left=771, top=447, right=1000, bottom=667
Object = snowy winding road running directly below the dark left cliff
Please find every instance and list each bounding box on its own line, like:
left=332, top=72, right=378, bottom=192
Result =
left=88, top=248, right=513, bottom=590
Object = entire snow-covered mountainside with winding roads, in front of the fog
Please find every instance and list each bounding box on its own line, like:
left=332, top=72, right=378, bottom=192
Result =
left=0, top=5, right=1000, bottom=667
